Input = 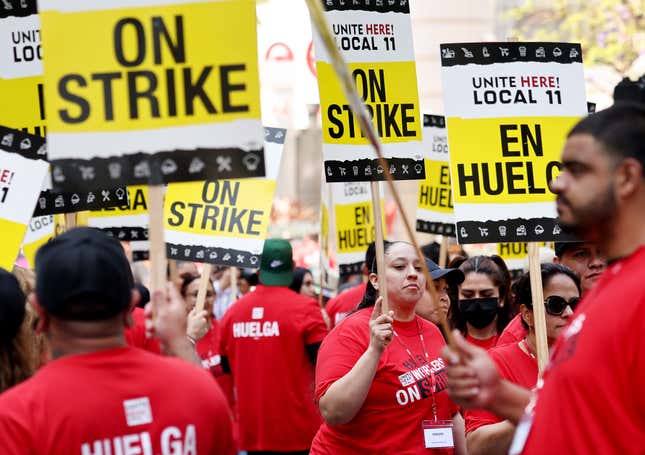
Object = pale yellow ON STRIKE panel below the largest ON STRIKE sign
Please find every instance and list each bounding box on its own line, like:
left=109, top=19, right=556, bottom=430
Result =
left=164, top=179, right=275, bottom=239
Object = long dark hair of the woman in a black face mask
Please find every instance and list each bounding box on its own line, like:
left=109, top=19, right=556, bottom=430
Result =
left=448, top=254, right=514, bottom=335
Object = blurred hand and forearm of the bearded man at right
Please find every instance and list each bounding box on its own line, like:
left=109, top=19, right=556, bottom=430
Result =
left=442, top=330, right=531, bottom=424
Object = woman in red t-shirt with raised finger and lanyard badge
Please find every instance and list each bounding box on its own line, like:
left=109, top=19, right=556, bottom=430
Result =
left=311, top=242, right=464, bottom=455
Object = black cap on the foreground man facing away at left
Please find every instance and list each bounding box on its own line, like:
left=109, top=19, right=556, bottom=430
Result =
left=36, top=227, right=134, bottom=321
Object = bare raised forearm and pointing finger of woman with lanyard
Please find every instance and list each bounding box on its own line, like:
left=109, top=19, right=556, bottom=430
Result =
left=319, top=297, right=394, bottom=425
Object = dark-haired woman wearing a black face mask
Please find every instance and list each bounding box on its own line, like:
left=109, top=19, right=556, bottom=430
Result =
left=449, top=255, right=513, bottom=349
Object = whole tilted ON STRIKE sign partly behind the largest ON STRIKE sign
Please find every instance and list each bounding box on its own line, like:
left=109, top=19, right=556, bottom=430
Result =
left=164, top=128, right=286, bottom=267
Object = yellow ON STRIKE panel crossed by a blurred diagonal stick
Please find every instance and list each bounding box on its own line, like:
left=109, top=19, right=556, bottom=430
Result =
left=316, top=62, right=422, bottom=145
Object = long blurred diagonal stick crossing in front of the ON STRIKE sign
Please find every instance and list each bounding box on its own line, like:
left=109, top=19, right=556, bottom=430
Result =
left=306, top=0, right=454, bottom=347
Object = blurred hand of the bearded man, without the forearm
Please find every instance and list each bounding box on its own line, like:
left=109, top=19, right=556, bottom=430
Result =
left=442, top=330, right=502, bottom=409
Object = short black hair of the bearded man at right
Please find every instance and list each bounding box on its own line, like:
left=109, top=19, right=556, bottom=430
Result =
left=568, top=101, right=645, bottom=174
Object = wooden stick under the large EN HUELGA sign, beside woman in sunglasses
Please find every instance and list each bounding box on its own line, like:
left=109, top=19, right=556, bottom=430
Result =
left=528, top=242, right=549, bottom=376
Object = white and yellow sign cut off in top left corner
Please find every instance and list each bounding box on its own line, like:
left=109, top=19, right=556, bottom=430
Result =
left=0, top=0, right=45, bottom=136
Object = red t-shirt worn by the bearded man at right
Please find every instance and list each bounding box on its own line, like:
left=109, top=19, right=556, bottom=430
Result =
left=523, top=247, right=645, bottom=455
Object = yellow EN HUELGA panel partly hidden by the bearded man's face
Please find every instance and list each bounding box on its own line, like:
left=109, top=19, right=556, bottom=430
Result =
left=448, top=117, right=580, bottom=204
